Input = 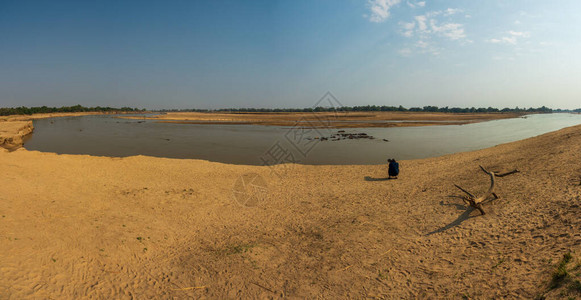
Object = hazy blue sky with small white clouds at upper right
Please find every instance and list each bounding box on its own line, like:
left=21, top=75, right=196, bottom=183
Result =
left=0, top=0, right=581, bottom=109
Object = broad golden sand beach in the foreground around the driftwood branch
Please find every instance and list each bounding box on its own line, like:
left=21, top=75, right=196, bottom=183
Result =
left=0, top=117, right=581, bottom=299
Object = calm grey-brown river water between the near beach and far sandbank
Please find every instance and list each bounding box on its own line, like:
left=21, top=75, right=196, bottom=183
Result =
left=24, top=114, right=581, bottom=165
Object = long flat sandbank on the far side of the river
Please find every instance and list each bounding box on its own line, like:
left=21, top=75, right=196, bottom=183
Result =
left=124, top=112, right=523, bottom=128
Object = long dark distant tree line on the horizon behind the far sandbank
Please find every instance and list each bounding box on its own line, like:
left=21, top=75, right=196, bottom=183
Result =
left=154, top=105, right=568, bottom=113
